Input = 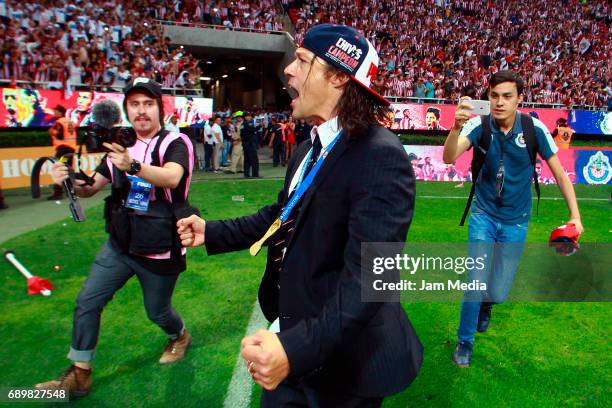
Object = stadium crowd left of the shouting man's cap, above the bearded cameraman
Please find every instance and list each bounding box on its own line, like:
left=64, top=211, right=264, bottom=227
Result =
left=0, top=0, right=283, bottom=90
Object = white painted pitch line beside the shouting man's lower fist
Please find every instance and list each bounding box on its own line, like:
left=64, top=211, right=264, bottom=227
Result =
left=223, top=301, right=268, bottom=408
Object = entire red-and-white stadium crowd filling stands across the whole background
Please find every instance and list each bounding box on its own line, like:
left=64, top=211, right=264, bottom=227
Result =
left=0, top=0, right=612, bottom=106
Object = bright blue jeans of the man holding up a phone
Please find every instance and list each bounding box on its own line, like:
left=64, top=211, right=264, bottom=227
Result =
left=457, top=212, right=529, bottom=343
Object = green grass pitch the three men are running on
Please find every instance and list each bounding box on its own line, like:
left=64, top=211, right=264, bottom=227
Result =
left=0, top=179, right=612, bottom=407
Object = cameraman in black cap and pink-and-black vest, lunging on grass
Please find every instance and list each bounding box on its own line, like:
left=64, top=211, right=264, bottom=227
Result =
left=36, top=78, right=193, bottom=397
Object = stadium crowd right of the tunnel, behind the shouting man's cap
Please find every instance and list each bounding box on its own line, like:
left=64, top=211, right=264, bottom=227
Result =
left=289, top=0, right=612, bottom=106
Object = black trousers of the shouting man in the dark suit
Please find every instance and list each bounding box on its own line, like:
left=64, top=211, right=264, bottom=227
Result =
left=259, top=381, right=383, bottom=408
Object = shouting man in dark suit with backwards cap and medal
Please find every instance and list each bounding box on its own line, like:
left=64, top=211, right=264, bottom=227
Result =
left=177, top=25, right=423, bottom=407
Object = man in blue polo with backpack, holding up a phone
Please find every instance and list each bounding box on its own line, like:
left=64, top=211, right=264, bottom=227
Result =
left=443, top=70, right=583, bottom=367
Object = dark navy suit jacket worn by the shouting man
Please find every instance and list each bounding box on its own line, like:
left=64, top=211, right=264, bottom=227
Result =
left=205, top=127, right=423, bottom=397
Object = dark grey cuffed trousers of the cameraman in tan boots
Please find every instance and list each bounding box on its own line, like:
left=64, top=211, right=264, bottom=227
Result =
left=68, top=242, right=183, bottom=361
